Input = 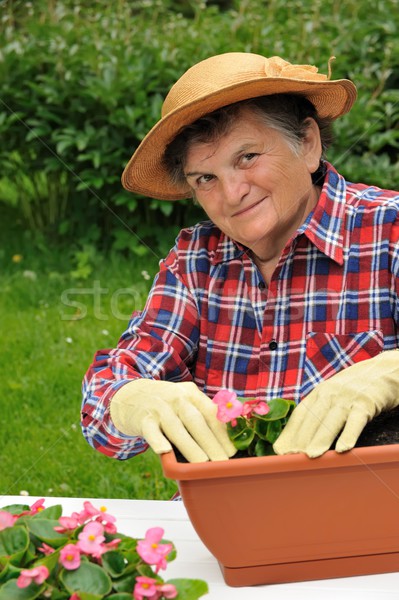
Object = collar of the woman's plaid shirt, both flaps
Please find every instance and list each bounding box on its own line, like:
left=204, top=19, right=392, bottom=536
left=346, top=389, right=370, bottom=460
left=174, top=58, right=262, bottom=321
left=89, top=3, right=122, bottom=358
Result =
left=211, top=162, right=346, bottom=265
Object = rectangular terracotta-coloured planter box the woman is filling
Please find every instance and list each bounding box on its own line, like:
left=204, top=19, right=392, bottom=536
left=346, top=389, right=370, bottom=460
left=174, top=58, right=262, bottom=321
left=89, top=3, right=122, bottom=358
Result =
left=162, top=444, right=399, bottom=586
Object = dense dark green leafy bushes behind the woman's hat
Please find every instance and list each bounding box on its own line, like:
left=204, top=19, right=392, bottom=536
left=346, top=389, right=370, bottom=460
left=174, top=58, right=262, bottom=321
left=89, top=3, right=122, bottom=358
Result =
left=0, top=0, right=399, bottom=255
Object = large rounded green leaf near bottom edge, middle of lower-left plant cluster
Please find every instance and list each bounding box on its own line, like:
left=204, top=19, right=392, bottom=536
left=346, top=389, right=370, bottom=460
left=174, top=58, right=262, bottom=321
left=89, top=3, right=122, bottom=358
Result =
left=60, top=562, right=112, bottom=600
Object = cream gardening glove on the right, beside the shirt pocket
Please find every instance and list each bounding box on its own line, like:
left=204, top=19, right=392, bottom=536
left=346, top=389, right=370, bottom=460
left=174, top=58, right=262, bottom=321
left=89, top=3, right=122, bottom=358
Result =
left=273, top=350, right=399, bottom=458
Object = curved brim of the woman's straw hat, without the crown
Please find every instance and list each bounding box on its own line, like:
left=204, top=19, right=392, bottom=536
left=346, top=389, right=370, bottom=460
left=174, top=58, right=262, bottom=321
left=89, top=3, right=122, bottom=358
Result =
left=122, top=77, right=357, bottom=200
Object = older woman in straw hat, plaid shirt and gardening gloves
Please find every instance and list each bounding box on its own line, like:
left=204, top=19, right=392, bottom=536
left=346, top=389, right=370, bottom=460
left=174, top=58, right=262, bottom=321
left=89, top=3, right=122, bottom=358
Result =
left=82, top=53, right=399, bottom=461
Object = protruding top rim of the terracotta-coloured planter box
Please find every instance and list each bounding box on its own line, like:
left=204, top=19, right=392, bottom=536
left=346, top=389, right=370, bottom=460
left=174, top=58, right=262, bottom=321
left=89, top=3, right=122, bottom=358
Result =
left=161, top=444, right=399, bottom=481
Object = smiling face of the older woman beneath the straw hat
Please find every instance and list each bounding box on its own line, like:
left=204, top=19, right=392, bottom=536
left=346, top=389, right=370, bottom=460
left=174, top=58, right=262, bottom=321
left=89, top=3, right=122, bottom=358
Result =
left=184, top=111, right=321, bottom=260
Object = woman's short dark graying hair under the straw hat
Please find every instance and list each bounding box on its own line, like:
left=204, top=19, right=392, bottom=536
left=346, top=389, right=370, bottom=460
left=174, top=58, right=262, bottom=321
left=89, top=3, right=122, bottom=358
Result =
left=163, top=94, right=332, bottom=185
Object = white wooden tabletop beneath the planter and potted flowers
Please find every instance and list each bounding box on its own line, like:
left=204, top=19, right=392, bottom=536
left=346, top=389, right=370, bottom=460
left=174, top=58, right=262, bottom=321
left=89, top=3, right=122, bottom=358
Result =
left=0, top=496, right=399, bottom=600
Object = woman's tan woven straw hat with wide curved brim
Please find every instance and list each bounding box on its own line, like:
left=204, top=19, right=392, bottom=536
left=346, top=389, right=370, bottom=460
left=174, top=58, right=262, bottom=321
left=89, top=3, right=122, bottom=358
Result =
left=122, top=52, right=356, bottom=200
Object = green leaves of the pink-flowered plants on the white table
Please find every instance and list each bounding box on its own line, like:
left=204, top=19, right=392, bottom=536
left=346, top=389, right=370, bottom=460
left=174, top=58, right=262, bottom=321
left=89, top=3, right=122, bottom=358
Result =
left=0, top=505, right=208, bottom=600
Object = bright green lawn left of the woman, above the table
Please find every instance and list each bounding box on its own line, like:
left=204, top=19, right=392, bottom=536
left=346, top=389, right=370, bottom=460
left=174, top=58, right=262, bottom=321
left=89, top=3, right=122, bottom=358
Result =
left=0, top=223, right=176, bottom=499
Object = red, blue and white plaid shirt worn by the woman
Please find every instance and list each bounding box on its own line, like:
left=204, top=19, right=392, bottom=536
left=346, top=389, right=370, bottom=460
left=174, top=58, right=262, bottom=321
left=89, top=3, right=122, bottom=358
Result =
left=82, top=165, right=399, bottom=459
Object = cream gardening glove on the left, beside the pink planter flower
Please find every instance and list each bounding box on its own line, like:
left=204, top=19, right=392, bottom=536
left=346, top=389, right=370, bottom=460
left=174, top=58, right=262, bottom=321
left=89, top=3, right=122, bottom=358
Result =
left=110, top=379, right=236, bottom=462
